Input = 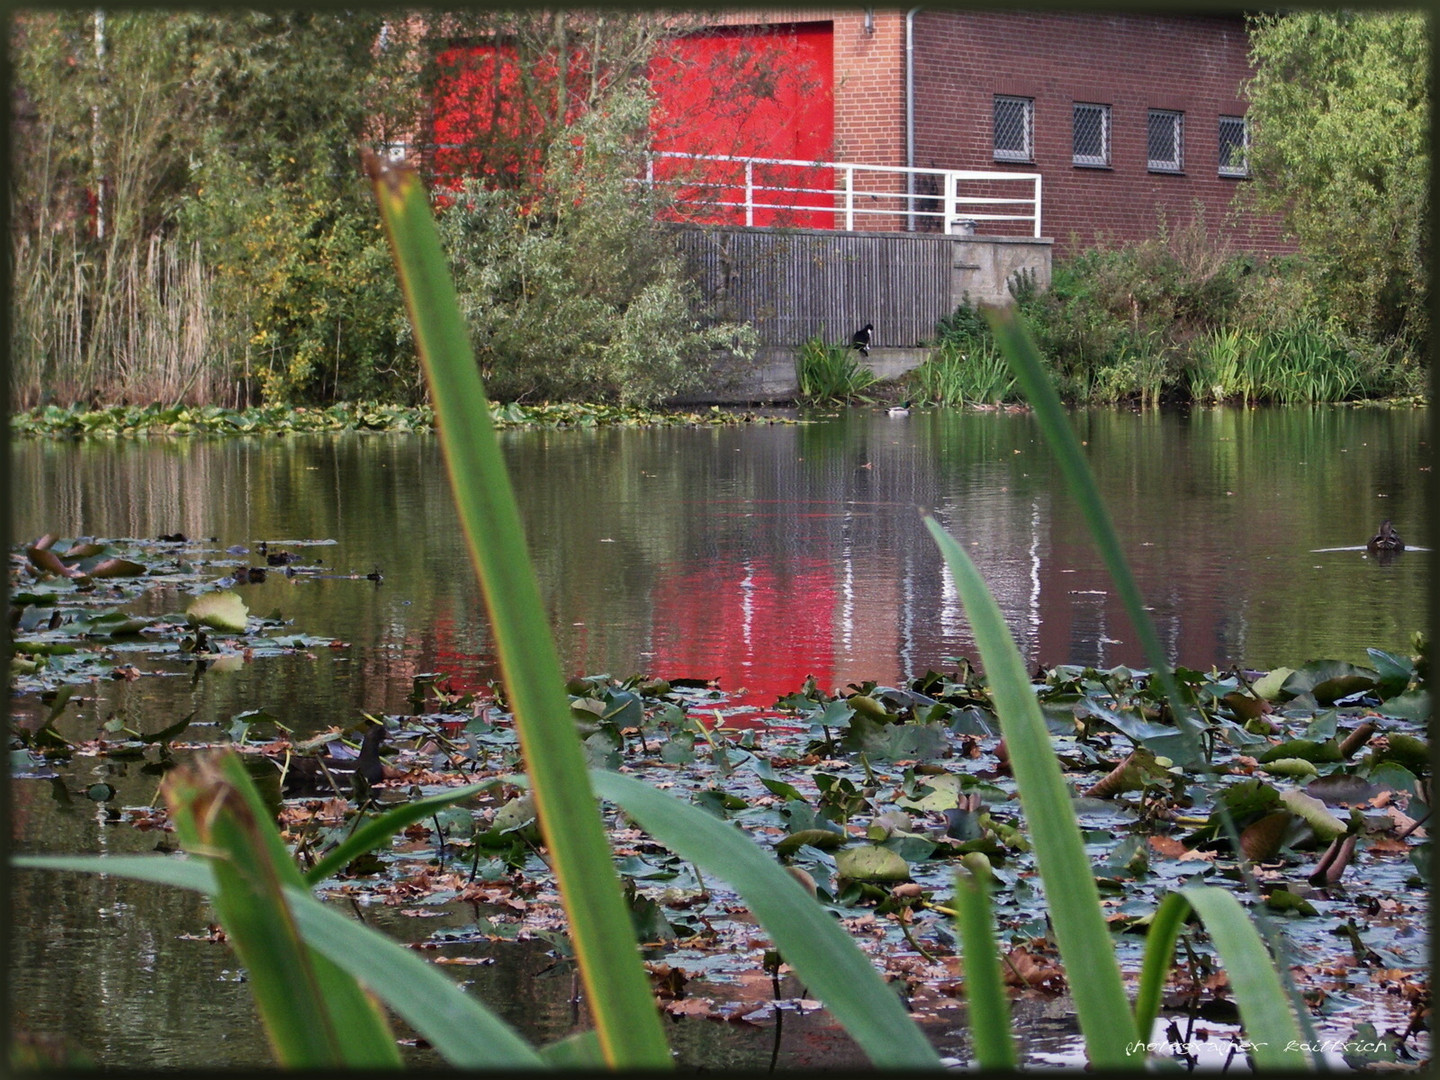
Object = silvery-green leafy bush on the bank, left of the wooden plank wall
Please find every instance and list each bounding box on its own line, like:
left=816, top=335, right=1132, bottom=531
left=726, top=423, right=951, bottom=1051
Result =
left=439, top=94, right=750, bottom=405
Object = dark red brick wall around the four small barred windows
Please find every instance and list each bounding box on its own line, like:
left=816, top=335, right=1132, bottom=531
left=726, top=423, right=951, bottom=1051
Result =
left=904, top=12, right=1290, bottom=255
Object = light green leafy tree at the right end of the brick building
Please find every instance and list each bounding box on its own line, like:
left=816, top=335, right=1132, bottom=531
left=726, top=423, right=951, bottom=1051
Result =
left=1247, top=12, right=1430, bottom=357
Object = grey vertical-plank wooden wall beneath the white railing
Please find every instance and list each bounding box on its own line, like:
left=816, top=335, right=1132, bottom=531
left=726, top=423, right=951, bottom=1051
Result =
left=678, top=226, right=956, bottom=348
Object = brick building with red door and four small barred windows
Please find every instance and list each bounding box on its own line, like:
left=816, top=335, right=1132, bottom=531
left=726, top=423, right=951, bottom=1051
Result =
left=653, top=9, right=1289, bottom=253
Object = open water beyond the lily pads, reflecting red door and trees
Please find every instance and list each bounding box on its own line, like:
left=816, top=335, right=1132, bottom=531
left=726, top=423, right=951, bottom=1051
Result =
left=13, top=409, right=1428, bottom=722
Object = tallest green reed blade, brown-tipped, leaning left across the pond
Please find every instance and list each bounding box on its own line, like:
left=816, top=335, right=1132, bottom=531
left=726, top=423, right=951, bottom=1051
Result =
left=366, top=153, right=671, bottom=1067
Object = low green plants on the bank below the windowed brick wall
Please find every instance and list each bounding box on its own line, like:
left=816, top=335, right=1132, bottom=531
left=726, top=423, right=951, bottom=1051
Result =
left=938, top=194, right=1424, bottom=405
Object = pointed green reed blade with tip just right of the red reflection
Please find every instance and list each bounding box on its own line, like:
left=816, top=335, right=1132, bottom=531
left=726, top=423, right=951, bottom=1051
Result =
left=924, top=517, right=1135, bottom=1068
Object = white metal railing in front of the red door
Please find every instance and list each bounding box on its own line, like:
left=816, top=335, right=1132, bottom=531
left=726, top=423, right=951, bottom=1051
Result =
left=645, top=151, right=1040, bottom=238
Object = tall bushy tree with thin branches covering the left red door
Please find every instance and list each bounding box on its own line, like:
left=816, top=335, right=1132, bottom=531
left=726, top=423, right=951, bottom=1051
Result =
left=414, top=9, right=753, bottom=403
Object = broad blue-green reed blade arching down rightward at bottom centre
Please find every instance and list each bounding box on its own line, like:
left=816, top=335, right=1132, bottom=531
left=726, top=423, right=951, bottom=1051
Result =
left=590, top=770, right=940, bottom=1068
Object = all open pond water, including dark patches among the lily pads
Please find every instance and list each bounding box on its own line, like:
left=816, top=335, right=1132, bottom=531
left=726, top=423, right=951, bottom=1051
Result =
left=10, top=409, right=1430, bottom=1067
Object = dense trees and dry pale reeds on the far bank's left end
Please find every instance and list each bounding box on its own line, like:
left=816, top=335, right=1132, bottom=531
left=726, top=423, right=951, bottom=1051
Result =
left=12, top=10, right=418, bottom=405
